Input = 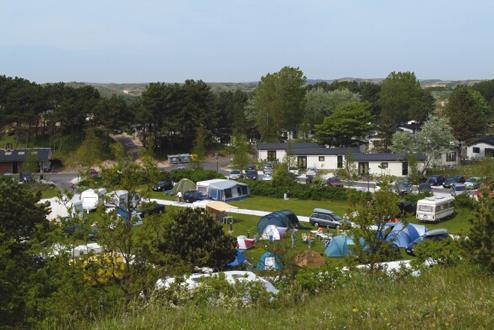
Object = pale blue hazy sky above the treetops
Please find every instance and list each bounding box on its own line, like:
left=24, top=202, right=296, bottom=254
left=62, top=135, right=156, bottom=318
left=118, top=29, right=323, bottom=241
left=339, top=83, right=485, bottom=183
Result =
left=0, top=0, right=494, bottom=83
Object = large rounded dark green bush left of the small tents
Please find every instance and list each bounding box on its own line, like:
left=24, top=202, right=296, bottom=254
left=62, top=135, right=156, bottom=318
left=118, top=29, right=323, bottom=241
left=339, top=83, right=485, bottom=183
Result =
left=158, top=208, right=235, bottom=269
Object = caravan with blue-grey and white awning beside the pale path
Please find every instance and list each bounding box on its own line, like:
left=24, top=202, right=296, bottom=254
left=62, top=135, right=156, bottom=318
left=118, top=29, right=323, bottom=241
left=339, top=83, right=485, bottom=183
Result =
left=197, top=179, right=249, bottom=201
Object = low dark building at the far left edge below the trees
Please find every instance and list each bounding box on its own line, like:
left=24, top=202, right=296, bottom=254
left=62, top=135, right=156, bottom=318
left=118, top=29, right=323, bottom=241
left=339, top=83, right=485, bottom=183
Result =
left=0, top=148, right=51, bottom=174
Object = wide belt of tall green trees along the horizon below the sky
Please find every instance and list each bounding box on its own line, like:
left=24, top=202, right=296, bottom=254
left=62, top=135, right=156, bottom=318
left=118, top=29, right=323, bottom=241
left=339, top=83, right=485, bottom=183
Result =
left=0, top=67, right=494, bottom=155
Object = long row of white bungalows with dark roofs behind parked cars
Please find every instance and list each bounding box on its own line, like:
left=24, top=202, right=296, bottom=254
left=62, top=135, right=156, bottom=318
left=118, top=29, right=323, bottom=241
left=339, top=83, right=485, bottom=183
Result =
left=257, top=143, right=425, bottom=176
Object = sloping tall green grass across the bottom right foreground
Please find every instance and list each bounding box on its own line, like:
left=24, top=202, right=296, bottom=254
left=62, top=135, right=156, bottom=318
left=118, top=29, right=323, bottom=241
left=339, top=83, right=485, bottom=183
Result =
left=90, top=265, right=494, bottom=329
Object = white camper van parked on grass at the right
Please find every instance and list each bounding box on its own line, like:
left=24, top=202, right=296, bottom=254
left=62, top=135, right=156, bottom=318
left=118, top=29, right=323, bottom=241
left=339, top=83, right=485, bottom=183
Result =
left=417, top=196, right=455, bottom=222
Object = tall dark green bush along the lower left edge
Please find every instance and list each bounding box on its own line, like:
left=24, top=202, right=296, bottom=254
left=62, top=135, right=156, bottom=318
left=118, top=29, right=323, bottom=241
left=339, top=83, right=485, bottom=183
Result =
left=0, top=178, right=49, bottom=327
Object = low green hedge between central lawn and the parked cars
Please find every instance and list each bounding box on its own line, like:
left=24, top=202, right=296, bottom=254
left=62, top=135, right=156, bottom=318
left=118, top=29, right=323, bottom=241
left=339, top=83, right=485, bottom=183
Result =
left=246, top=181, right=367, bottom=200
